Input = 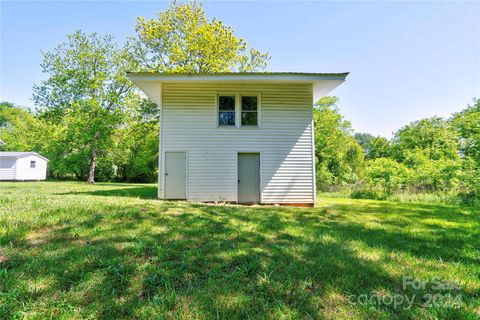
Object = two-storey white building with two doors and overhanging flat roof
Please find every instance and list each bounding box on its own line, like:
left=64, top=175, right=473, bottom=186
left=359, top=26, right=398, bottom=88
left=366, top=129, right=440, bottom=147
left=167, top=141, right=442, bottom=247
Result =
left=129, top=72, right=347, bottom=206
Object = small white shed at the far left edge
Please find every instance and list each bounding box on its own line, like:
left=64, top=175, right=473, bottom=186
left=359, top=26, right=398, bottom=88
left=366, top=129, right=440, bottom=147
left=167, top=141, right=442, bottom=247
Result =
left=0, top=151, right=48, bottom=181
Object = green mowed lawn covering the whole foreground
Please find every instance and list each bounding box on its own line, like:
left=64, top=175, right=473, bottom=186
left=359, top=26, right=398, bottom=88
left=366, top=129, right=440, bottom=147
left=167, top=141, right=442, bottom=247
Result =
left=0, top=182, right=480, bottom=319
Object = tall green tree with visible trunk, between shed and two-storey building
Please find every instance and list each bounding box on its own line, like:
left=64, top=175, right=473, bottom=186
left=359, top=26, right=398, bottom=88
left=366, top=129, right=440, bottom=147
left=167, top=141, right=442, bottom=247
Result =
left=33, top=31, right=136, bottom=183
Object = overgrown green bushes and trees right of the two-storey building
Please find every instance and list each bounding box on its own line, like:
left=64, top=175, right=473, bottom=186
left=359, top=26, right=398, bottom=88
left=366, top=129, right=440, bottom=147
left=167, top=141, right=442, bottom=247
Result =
left=314, top=97, right=480, bottom=206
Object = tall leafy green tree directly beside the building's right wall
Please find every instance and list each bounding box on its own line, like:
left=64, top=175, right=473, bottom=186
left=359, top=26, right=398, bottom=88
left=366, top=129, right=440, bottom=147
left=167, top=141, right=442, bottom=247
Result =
left=313, top=96, right=363, bottom=191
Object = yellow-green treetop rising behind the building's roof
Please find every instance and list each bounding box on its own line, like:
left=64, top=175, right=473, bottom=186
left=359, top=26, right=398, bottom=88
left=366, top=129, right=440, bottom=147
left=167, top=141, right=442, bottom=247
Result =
left=129, top=1, right=270, bottom=73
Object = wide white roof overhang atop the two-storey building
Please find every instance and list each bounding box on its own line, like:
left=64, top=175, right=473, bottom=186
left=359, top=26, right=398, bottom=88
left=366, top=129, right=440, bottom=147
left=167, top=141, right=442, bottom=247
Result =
left=128, top=72, right=348, bottom=105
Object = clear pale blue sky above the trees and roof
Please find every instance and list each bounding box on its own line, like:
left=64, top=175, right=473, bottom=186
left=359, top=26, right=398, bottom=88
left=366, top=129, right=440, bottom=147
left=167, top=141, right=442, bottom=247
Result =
left=0, top=1, right=480, bottom=137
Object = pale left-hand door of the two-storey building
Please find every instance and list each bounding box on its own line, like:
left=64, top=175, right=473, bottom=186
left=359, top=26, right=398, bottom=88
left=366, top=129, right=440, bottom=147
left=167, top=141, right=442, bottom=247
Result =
left=165, top=152, right=187, bottom=199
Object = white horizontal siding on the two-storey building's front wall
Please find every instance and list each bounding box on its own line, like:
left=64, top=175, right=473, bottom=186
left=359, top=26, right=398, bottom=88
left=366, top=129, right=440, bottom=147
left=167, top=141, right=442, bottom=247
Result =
left=159, top=83, right=314, bottom=203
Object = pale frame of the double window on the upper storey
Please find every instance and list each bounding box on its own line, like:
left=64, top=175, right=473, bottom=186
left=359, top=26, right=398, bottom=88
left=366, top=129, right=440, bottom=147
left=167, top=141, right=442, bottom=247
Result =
left=215, top=91, right=262, bottom=130
